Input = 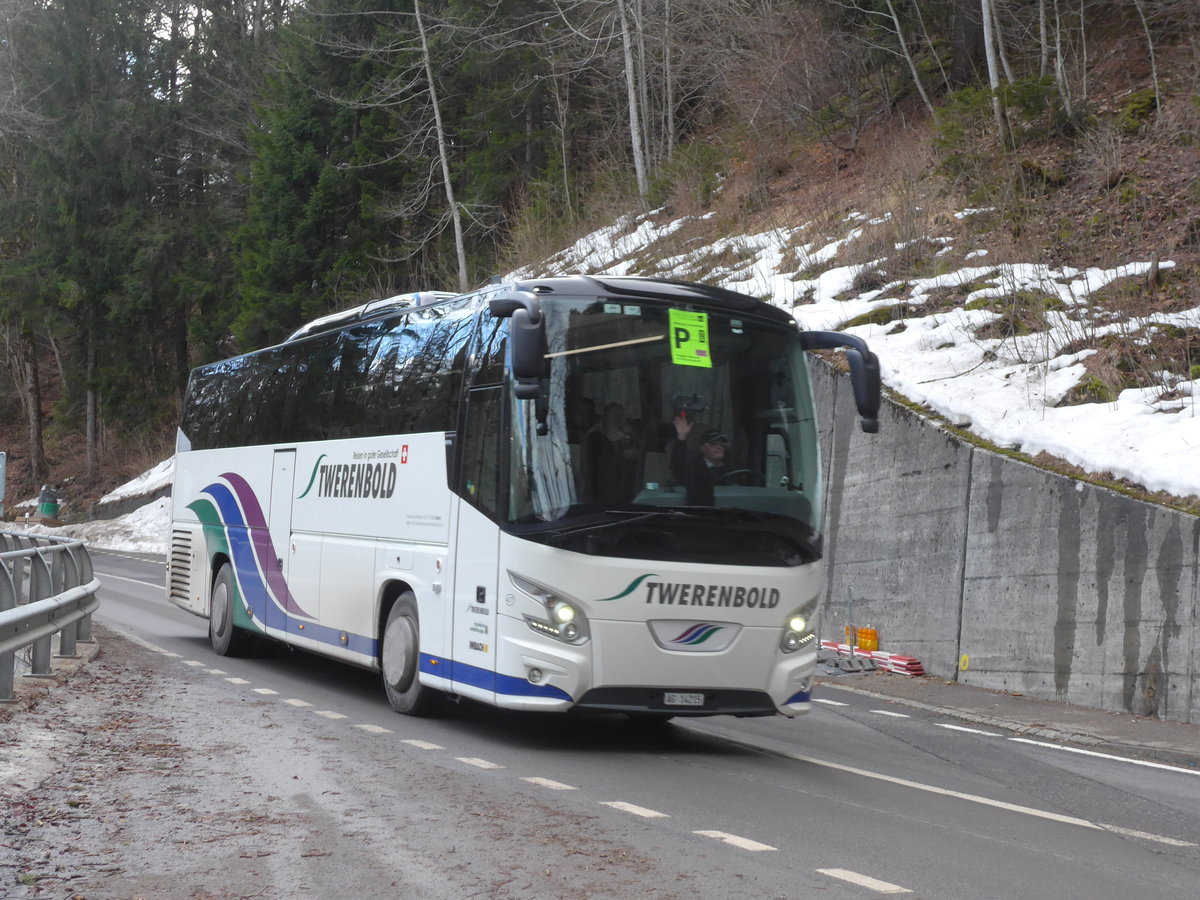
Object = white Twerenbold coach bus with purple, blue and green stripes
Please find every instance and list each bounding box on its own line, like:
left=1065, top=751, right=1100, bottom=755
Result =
left=167, top=276, right=880, bottom=718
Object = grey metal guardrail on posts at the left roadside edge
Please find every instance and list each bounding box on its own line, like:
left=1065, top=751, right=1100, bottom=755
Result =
left=0, top=532, right=100, bottom=703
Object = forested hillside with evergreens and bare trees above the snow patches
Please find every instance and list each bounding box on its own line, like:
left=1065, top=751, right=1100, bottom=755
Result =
left=0, top=0, right=1200, bottom=505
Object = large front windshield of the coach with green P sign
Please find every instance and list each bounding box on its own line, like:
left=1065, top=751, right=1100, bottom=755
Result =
left=505, top=298, right=822, bottom=565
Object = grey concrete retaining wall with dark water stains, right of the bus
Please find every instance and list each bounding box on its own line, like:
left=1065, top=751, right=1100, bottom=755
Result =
left=814, top=362, right=1200, bottom=722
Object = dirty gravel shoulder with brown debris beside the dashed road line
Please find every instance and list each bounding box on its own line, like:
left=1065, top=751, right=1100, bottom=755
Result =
left=0, top=628, right=696, bottom=900
